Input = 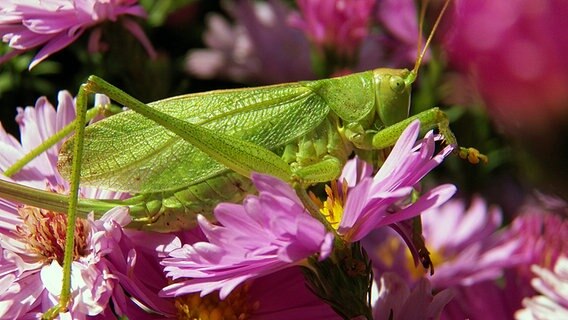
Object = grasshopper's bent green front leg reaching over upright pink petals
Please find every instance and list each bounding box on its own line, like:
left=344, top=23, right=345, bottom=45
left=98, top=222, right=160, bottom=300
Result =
left=372, top=108, right=488, bottom=164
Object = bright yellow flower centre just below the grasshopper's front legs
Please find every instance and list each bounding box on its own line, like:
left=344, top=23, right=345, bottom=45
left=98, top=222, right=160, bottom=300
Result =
left=310, top=180, right=348, bottom=229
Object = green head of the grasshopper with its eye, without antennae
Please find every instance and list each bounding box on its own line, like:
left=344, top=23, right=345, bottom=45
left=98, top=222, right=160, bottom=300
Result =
left=373, top=68, right=416, bottom=126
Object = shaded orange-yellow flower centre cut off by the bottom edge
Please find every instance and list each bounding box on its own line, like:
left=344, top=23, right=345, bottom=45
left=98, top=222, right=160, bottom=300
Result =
left=175, top=282, right=260, bottom=320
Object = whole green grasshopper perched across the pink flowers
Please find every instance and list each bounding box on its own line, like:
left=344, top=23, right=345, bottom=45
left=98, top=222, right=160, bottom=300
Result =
left=0, top=1, right=485, bottom=318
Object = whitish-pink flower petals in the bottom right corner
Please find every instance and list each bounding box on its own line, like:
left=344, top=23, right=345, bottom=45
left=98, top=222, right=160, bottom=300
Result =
left=515, top=256, right=568, bottom=320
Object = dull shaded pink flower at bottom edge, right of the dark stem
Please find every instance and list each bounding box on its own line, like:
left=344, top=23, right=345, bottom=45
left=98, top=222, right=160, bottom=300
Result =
left=373, top=272, right=453, bottom=320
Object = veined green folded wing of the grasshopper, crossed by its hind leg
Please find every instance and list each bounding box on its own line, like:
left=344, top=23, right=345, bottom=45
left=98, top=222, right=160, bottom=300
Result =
left=59, top=83, right=329, bottom=193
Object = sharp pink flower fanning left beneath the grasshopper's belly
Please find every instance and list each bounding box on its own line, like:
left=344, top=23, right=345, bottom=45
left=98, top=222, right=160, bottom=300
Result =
left=162, top=174, right=333, bottom=299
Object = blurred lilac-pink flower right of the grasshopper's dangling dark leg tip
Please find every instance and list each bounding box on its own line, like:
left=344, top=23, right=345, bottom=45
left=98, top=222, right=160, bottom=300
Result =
left=422, top=197, right=527, bottom=288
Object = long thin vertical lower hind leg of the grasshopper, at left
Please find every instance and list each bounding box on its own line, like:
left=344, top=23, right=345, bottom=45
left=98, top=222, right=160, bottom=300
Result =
left=42, top=84, right=87, bottom=319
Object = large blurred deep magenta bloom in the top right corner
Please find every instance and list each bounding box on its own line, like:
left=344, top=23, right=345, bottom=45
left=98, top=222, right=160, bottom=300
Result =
left=445, top=0, right=568, bottom=132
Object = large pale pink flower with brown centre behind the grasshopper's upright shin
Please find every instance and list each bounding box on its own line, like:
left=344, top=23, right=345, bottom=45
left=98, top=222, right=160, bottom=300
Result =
left=0, top=92, right=173, bottom=319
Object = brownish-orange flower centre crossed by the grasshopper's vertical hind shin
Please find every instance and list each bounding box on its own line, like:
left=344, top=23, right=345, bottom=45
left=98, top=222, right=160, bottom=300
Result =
left=16, top=206, right=89, bottom=265
